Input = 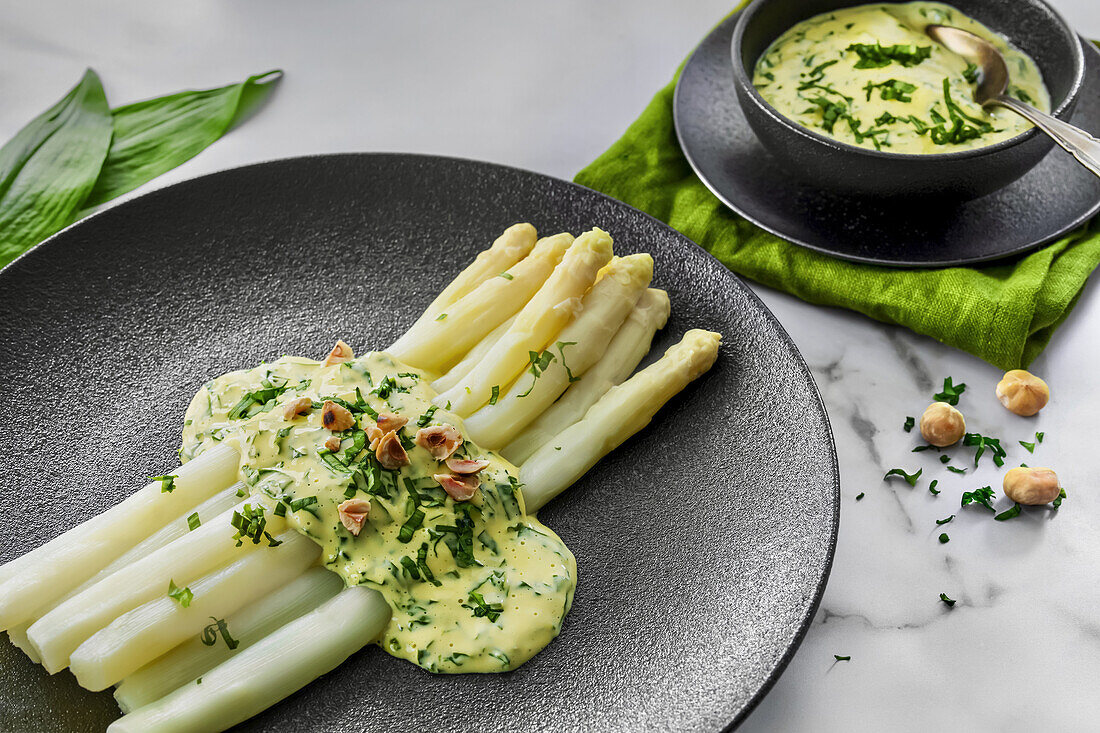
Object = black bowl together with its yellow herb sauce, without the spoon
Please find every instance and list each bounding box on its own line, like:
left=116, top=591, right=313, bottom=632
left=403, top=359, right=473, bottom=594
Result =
left=732, top=0, right=1085, bottom=198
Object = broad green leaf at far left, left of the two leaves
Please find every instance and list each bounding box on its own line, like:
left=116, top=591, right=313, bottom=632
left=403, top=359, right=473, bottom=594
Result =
left=0, top=68, right=111, bottom=266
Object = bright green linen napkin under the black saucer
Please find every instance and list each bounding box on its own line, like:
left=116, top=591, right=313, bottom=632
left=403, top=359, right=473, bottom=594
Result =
left=575, top=31, right=1100, bottom=370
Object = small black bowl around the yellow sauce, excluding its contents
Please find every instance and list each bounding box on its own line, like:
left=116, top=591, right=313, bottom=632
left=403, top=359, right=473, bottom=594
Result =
left=732, top=0, right=1085, bottom=200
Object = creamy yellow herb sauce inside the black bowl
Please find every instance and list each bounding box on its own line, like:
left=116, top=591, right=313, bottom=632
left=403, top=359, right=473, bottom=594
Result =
left=752, top=2, right=1051, bottom=154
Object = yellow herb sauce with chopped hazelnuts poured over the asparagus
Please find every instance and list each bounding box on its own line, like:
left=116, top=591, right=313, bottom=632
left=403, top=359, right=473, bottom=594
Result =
left=180, top=352, right=576, bottom=672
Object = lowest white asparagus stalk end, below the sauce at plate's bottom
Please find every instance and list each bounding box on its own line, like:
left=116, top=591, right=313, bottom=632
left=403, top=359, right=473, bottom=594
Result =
left=107, top=586, right=389, bottom=733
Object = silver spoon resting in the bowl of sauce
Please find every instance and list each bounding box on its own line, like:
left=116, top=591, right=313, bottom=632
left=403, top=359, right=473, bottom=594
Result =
left=924, top=25, right=1100, bottom=176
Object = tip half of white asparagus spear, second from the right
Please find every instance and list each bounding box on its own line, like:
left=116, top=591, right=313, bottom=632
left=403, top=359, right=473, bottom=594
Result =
left=501, top=288, right=669, bottom=466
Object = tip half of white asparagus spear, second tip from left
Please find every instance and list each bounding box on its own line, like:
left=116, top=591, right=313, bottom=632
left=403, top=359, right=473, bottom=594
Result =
left=386, top=233, right=573, bottom=374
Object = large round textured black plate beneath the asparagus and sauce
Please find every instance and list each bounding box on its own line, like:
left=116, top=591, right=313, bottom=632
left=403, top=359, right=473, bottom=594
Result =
left=0, top=150, right=838, bottom=732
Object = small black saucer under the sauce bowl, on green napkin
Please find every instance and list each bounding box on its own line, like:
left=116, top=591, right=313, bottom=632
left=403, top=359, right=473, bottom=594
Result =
left=673, top=13, right=1100, bottom=267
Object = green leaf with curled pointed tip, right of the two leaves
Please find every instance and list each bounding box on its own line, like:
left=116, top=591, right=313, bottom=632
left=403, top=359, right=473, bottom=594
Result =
left=86, top=69, right=283, bottom=208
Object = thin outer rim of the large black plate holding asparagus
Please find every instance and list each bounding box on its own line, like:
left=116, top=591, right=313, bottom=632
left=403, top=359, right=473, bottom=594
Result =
left=0, top=152, right=840, bottom=731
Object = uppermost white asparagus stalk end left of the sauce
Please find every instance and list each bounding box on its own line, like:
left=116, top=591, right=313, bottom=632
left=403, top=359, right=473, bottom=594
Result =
left=0, top=446, right=240, bottom=630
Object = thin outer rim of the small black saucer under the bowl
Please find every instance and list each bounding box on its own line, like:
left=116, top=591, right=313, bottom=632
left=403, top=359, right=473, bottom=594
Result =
left=672, top=10, right=1100, bottom=270
